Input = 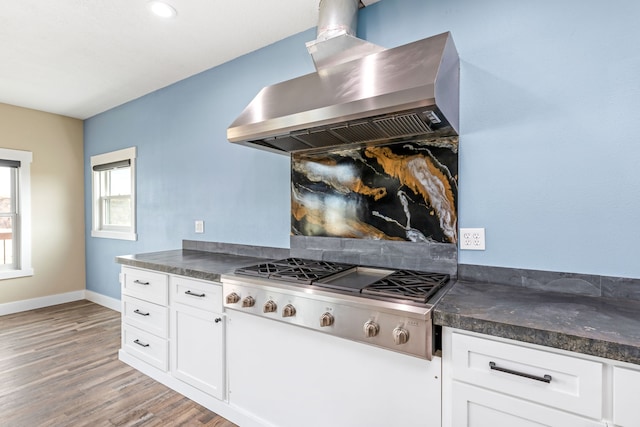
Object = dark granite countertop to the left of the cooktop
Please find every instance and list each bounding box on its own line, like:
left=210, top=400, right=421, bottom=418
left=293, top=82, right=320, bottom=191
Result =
left=116, top=249, right=265, bottom=282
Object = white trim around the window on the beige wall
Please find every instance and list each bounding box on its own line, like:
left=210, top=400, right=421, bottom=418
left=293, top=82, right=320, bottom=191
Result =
left=0, top=148, right=33, bottom=280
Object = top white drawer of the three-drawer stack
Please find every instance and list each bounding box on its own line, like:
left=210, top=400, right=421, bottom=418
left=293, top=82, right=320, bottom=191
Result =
left=122, top=267, right=169, bottom=305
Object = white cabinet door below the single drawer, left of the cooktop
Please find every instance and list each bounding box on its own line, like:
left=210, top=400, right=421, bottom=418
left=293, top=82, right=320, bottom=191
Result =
left=171, top=304, right=226, bottom=399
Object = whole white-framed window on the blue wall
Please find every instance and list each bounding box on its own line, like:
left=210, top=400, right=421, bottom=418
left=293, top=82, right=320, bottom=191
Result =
left=91, top=147, right=136, bottom=240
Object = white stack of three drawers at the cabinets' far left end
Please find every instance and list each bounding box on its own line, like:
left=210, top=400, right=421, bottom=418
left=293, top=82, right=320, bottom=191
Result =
left=121, top=267, right=169, bottom=371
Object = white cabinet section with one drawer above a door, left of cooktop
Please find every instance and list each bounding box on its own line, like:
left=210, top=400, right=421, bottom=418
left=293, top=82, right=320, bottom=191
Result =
left=170, top=276, right=226, bottom=399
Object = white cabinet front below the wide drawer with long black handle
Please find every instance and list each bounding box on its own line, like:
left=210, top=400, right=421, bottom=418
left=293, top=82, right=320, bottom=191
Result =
left=452, top=381, right=606, bottom=427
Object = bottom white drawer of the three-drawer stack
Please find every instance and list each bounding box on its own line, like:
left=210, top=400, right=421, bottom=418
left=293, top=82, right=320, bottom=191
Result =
left=122, top=324, right=169, bottom=372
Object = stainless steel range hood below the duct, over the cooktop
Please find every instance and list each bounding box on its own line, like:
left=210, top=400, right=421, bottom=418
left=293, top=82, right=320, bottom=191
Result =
left=227, top=32, right=460, bottom=153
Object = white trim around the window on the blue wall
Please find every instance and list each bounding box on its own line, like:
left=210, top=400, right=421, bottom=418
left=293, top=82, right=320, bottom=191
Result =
left=91, top=147, right=138, bottom=240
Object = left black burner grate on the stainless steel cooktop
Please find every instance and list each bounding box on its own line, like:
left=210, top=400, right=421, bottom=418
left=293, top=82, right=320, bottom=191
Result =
left=236, top=258, right=354, bottom=285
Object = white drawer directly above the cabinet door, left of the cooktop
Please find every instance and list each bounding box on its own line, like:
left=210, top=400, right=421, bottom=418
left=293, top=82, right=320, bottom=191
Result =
left=171, top=276, right=222, bottom=313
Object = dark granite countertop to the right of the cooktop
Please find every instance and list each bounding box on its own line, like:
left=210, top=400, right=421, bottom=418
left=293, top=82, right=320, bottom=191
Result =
left=434, top=281, right=640, bottom=364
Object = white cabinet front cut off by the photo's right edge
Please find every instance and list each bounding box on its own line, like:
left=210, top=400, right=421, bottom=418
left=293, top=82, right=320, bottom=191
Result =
left=613, top=366, right=640, bottom=427
